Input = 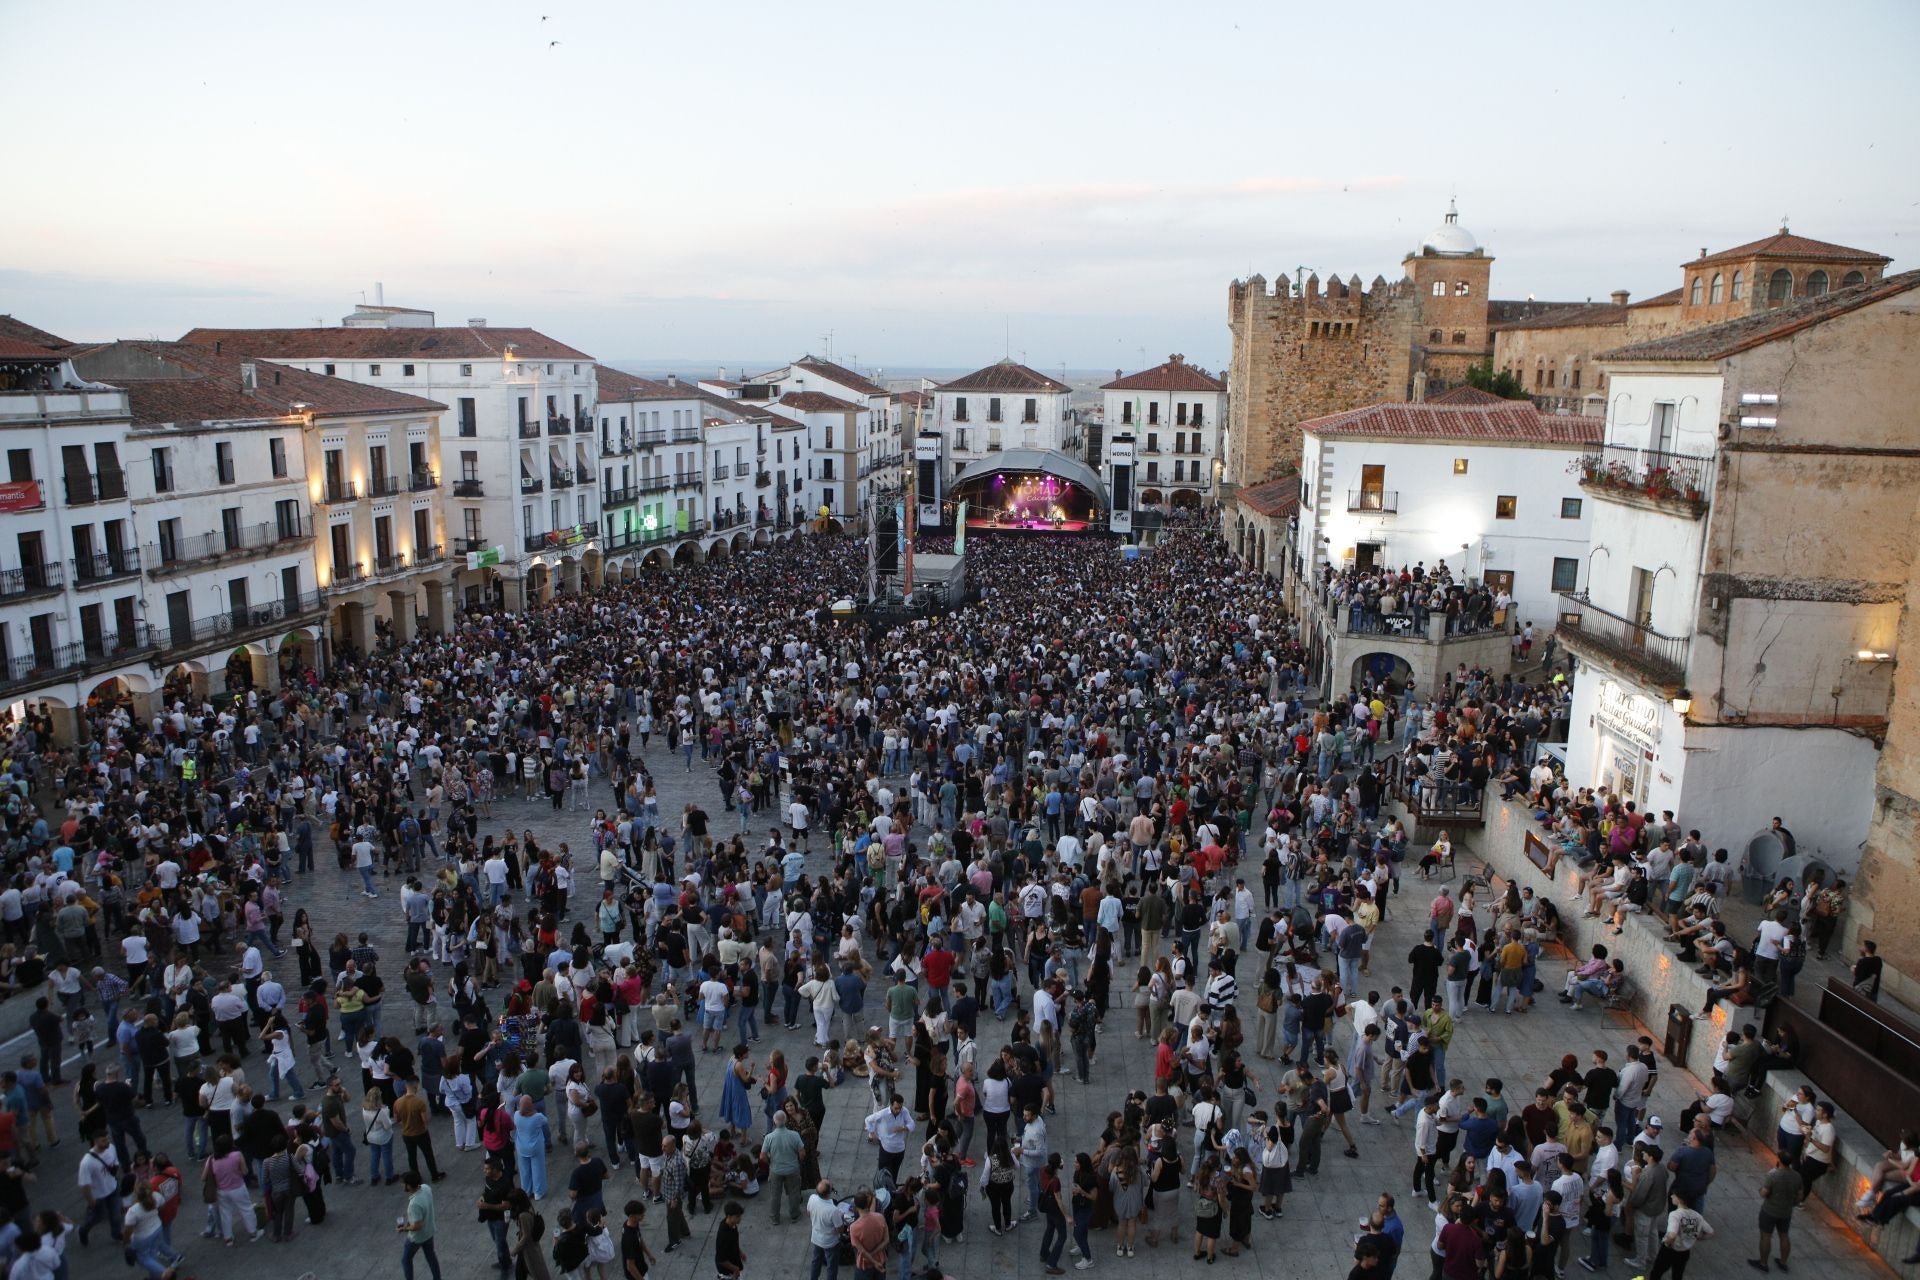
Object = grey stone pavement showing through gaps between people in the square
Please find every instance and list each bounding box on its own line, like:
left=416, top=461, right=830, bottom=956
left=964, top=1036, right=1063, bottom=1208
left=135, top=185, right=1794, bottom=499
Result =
left=18, top=750, right=1893, bottom=1280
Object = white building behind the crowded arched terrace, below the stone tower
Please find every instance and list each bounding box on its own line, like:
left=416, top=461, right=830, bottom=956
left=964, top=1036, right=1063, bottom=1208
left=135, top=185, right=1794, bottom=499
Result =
left=1269, top=393, right=1599, bottom=702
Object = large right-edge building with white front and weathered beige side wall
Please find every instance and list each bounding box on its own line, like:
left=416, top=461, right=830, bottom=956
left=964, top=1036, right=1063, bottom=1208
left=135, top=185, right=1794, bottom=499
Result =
left=1559, top=273, right=1920, bottom=875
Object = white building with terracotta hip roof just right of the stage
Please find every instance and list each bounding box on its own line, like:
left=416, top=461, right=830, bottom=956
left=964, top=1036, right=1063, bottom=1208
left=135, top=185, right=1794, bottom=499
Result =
left=1100, top=355, right=1227, bottom=507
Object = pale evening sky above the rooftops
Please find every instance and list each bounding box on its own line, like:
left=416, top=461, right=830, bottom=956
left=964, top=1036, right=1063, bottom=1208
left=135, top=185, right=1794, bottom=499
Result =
left=0, top=0, right=1920, bottom=368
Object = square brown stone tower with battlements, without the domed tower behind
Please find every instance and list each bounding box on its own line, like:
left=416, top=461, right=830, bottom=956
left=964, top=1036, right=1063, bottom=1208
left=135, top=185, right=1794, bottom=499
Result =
left=1227, top=274, right=1419, bottom=486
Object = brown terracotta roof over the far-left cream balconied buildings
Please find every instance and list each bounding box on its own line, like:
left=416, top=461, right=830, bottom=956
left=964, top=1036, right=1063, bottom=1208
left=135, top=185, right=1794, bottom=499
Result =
left=73, top=342, right=445, bottom=426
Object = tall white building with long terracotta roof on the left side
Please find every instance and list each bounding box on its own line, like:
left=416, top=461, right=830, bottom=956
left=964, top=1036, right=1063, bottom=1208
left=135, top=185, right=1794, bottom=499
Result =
left=184, top=307, right=603, bottom=606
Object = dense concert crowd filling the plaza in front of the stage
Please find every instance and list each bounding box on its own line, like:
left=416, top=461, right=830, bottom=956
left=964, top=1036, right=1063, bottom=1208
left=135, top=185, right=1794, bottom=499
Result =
left=0, top=526, right=1905, bottom=1280
